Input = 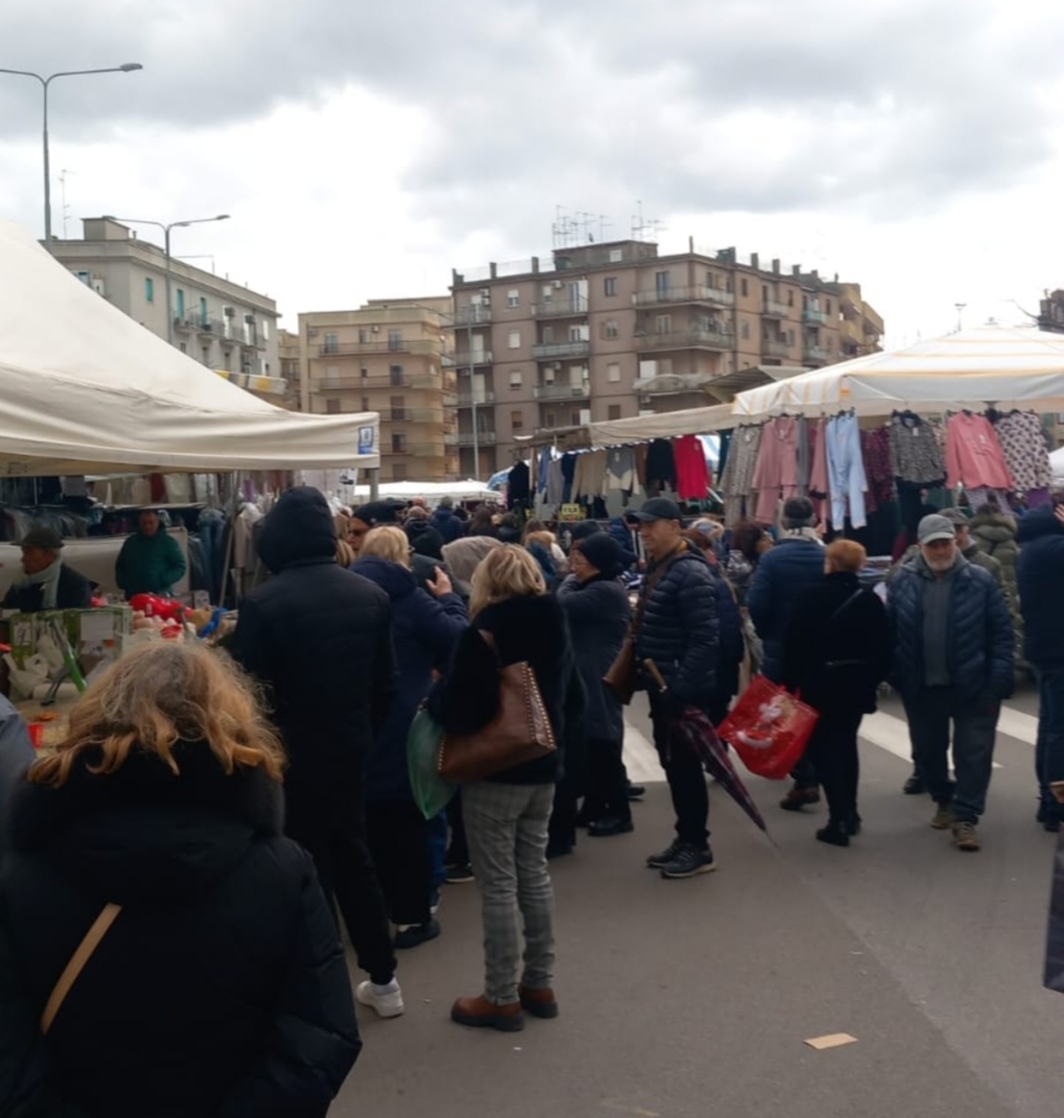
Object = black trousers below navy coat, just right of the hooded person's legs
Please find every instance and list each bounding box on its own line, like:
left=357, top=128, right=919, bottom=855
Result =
left=365, top=799, right=433, bottom=923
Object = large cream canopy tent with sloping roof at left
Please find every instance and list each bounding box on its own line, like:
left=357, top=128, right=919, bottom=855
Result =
left=0, top=222, right=380, bottom=476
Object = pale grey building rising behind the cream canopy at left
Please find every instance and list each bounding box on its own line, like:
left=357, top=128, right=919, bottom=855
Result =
left=46, top=217, right=286, bottom=404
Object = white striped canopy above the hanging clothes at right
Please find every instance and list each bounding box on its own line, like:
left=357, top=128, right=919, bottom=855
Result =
left=733, top=325, right=1064, bottom=421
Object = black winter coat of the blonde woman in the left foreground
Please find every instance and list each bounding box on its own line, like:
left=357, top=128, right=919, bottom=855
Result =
left=0, top=742, right=361, bottom=1118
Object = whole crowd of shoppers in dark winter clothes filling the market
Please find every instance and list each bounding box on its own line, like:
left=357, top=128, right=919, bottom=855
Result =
left=0, top=487, right=1064, bottom=1118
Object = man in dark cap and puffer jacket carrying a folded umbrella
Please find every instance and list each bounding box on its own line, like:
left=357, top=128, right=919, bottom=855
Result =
left=636, top=498, right=720, bottom=878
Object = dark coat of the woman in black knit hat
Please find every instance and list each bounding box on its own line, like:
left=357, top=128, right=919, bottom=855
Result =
left=558, top=575, right=631, bottom=741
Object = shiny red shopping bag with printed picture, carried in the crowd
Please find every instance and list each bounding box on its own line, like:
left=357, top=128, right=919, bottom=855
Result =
left=716, top=675, right=820, bottom=780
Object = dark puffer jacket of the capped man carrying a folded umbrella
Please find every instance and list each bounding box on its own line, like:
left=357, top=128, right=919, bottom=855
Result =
left=636, top=544, right=721, bottom=709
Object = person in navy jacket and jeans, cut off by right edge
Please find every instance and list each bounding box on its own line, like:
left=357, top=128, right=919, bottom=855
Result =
left=1016, top=500, right=1064, bottom=831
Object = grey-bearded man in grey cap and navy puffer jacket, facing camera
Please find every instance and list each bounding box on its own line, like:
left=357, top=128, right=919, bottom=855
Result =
left=887, top=515, right=1013, bottom=851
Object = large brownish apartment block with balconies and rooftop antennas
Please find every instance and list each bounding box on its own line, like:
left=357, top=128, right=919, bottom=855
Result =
left=452, top=240, right=882, bottom=477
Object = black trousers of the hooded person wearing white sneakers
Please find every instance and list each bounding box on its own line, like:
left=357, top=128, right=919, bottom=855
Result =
left=285, top=789, right=396, bottom=985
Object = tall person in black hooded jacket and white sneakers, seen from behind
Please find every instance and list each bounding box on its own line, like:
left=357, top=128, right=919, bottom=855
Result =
left=232, top=486, right=403, bottom=1016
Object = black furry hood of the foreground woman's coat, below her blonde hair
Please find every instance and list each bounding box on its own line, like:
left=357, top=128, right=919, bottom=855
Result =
left=9, top=742, right=284, bottom=904
